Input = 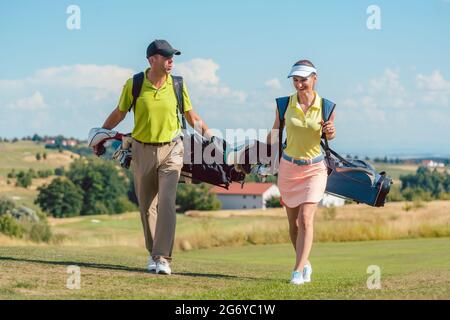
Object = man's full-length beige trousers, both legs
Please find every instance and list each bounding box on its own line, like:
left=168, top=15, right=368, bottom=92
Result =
left=132, top=139, right=184, bottom=262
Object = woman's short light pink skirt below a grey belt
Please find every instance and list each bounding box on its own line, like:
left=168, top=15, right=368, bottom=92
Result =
left=278, top=158, right=328, bottom=208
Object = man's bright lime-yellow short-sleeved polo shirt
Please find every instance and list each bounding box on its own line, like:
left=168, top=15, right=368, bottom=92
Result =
left=119, top=69, right=192, bottom=143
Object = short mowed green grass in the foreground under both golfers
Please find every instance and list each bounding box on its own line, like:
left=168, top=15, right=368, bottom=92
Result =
left=0, top=238, right=450, bottom=299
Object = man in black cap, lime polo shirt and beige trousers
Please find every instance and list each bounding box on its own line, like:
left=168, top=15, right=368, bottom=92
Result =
left=94, top=40, right=211, bottom=274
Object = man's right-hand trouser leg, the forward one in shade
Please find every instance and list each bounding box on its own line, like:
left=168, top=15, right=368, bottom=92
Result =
left=152, top=140, right=184, bottom=262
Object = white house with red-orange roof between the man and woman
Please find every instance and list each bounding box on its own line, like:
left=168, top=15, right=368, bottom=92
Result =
left=211, top=182, right=280, bottom=209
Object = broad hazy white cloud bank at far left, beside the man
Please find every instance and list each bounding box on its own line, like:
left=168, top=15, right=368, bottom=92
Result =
left=0, top=64, right=133, bottom=137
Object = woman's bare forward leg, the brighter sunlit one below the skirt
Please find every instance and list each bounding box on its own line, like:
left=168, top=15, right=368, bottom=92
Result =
left=294, top=203, right=318, bottom=272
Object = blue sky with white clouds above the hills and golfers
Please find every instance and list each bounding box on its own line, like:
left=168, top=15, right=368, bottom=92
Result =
left=0, top=0, right=450, bottom=155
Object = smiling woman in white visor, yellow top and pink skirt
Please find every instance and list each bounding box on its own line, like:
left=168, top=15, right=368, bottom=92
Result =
left=267, top=60, right=336, bottom=285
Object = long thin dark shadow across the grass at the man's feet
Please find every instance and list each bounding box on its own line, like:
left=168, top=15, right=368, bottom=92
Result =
left=0, top=257, right=251, bottom=280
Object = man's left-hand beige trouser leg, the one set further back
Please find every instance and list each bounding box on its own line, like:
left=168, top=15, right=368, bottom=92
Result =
left=133, top=142, right=158, bottom=254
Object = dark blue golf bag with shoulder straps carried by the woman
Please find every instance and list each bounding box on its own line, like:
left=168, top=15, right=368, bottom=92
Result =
left=277, top=97, right=392, bottom=207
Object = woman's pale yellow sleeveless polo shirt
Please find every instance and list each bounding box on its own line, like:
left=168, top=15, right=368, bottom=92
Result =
left=284, top=92, right=322, bottom=159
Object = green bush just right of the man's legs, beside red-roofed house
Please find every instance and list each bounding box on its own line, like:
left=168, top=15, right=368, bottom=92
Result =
left=176, top=184, right=221, bottom=212
